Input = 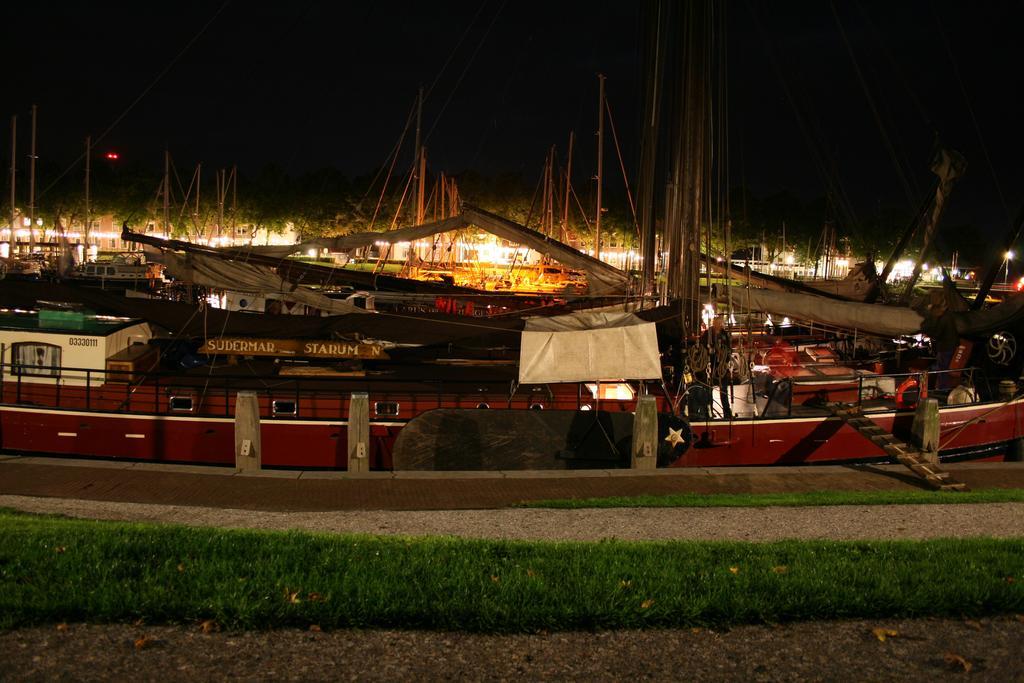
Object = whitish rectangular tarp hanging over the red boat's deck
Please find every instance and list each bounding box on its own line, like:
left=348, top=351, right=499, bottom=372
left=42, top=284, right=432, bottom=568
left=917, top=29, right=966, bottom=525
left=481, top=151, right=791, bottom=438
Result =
left=519, top=323, right=662, bottom=384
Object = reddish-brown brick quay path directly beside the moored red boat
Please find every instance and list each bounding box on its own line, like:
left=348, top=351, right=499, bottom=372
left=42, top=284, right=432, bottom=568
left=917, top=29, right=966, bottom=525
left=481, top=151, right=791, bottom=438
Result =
left=0, top=456, right=1024, bottom=511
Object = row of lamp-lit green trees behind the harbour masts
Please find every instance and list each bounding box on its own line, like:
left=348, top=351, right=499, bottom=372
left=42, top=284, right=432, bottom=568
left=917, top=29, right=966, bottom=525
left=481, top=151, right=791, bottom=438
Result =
left=6, top=161, right=910, bottom=258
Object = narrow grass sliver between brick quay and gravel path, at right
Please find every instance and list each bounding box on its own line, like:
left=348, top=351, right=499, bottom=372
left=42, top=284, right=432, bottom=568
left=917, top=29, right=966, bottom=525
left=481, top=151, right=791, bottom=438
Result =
left=522, top=488, right=1024, bottom=509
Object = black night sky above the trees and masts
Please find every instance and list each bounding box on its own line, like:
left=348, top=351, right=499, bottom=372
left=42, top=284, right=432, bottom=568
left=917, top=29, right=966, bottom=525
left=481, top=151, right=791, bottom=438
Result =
left=0, top=0, right=1024, bottom=245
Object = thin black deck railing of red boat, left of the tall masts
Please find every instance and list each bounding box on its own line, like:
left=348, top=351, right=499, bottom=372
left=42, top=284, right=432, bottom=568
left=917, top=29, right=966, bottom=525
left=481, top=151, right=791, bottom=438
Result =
left=0, top=364, right=655, bottom=420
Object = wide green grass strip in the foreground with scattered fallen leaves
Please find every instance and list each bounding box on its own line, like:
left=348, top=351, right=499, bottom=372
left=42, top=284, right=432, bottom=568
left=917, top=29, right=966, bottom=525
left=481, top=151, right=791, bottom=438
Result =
left=0, top=512, right=1024, bottom=632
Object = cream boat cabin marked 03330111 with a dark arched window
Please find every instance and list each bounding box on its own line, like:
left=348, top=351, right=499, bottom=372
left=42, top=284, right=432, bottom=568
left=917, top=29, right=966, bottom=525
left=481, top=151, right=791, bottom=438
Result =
left=0, top=309, right=156, bottom=386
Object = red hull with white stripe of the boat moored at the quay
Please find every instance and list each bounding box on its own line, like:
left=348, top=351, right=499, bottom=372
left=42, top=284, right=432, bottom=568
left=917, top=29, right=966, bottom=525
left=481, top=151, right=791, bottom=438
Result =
left=0, top=386, right=1024, bottom=469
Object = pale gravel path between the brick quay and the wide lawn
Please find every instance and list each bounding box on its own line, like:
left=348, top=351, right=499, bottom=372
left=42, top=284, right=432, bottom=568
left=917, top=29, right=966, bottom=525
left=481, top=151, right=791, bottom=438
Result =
left=0, top=496, right=1024, bottom=542
